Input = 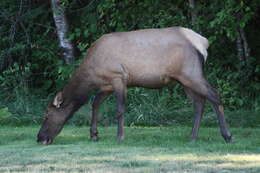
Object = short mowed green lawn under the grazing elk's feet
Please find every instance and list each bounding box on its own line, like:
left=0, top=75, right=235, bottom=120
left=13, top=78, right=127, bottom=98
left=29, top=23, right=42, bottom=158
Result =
left=0, top=126, right=260, bottom=173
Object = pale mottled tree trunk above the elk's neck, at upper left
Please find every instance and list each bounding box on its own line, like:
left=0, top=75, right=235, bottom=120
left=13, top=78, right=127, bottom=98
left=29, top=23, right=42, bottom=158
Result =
left=51, top=0, right=75, bottom=63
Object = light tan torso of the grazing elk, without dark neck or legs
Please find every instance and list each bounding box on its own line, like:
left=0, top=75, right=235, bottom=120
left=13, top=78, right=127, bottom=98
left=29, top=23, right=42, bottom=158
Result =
left=78, top=27, right=201, bottom=91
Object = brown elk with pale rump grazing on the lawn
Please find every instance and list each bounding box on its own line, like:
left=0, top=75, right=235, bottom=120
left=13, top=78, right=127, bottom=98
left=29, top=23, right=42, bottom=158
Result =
left=37, top=27, right=232, bottom=144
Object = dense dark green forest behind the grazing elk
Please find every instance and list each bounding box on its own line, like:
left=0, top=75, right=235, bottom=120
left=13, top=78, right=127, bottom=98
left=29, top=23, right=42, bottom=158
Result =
left=0, top=0, right=260, bottom=127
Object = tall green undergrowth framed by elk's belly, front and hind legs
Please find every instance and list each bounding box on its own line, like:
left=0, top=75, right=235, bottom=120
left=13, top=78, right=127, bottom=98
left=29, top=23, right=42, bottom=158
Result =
left=126, top=86, right=192, bottom=126
